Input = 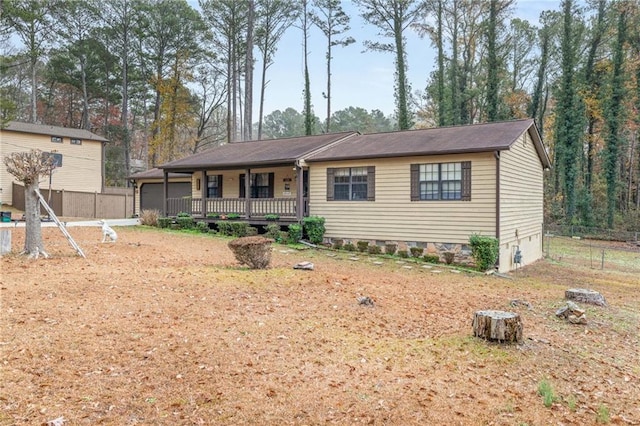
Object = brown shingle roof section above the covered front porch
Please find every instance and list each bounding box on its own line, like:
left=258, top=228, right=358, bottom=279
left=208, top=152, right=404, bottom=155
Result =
left=160, top=132, right=357, bottom=172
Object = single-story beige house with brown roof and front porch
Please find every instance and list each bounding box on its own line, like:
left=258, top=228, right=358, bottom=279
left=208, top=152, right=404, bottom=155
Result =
left=155, top=119, right=550, bottom=271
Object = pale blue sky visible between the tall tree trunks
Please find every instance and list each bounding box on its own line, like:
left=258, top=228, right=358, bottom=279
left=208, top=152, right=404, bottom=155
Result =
left=254, top=0, right=560, bottom=120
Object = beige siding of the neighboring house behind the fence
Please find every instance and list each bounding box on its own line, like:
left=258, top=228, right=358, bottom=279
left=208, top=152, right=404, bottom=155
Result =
left=0, top=130, right=102, bottom=204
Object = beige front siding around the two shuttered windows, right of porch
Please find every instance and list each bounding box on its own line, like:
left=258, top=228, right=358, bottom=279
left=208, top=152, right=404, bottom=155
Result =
left=309, top=153, right=496, bottom=244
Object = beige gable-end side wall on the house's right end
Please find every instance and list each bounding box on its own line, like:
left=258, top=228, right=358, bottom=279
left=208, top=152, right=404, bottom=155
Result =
left=500, top=132, right=544, bottom=270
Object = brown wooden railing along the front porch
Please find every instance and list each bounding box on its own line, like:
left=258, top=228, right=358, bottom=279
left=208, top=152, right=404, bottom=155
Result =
left=167, top=198, right=308, bottom=218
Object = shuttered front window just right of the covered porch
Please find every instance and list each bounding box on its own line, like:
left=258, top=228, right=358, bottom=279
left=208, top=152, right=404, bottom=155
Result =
left=327, top=166, right=376, bottom=201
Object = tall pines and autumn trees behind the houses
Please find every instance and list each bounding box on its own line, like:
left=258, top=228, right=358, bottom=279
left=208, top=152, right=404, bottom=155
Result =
left=0, top=0, right=640, bottom=231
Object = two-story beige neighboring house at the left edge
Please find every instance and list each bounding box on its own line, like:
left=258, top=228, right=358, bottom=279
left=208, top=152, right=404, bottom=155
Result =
left=0, top=121, right=108, bottom=204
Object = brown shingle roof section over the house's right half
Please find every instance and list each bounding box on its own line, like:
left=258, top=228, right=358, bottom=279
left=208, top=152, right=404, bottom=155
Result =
left=305, top=119, right=549, bottom=168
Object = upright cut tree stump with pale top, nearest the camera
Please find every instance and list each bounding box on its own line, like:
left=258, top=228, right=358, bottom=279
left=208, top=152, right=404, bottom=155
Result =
left=473, top=311, right=522, bottom=343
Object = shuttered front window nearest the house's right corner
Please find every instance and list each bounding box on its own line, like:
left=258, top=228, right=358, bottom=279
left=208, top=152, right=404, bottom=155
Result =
left=411, top=161, right=471, bottom=201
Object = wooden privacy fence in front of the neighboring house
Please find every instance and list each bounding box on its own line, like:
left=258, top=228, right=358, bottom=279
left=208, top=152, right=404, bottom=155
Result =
left=12, top=183, right=134, bottom=219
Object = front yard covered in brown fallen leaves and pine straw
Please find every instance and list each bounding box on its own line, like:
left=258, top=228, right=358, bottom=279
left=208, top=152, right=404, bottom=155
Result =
left=0, top=227, right=640, bottom=425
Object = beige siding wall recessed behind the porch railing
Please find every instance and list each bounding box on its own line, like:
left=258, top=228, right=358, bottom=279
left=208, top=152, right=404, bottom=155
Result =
left=191, top=165, right=297, bottom=198
